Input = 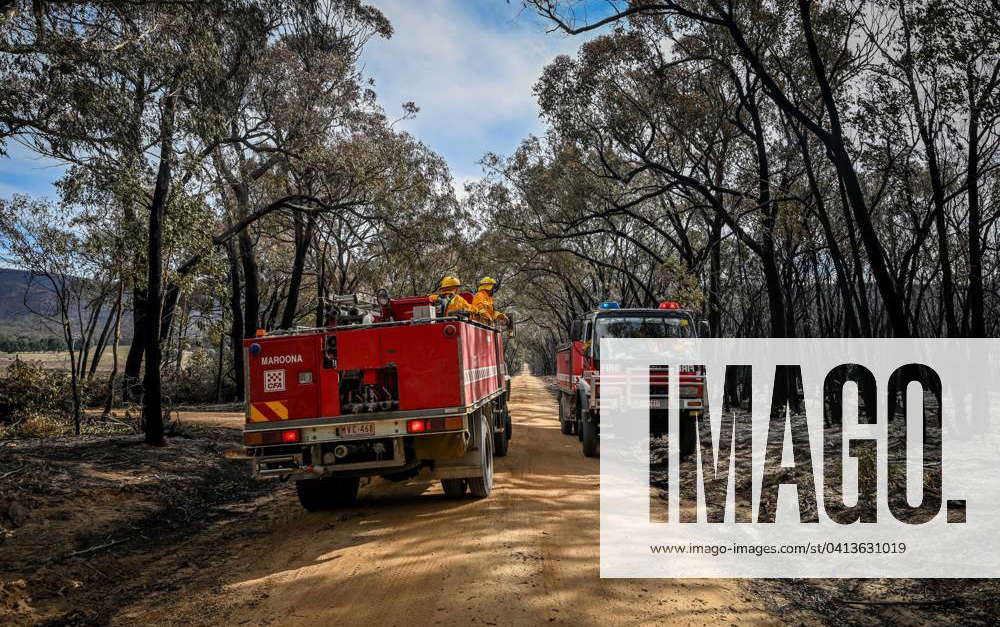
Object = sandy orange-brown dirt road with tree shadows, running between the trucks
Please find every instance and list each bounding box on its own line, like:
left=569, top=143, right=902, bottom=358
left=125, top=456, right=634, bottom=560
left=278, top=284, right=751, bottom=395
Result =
left=133, top=375, right=774, bottom=626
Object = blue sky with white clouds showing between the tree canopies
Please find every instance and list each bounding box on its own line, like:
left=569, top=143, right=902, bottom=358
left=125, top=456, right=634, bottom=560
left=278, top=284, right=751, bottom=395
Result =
left=0, top=0, right=584, bottom=198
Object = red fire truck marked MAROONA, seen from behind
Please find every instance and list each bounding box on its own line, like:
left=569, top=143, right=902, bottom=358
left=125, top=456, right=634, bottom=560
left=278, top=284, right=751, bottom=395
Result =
left=244, top=290, right=511, bottom=511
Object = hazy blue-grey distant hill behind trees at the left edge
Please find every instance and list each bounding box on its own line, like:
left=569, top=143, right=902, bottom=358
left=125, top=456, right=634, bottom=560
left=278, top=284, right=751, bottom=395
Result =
left=0, top=268, right=132, bottom=352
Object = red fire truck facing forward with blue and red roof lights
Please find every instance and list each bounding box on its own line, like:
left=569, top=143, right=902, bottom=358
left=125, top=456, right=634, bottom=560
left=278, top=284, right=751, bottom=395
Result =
left=556, top=301, right=708, bottom=457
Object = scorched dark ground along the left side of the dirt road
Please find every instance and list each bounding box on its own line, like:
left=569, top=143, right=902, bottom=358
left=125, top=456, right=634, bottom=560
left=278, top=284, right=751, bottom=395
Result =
left=0, top=425, right=274, bottom=625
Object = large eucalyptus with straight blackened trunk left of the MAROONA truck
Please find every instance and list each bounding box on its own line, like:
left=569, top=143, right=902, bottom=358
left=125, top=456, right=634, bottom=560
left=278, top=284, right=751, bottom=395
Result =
left=0, top=0, right=389, bottom=444
